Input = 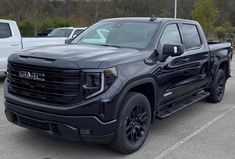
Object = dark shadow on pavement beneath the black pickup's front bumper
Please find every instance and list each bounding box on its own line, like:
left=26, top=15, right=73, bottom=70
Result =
left=17, top=129, right=122, bottom=159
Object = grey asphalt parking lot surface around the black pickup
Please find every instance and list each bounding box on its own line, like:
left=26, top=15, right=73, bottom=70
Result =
left=0, top=59, right=235, bottom=159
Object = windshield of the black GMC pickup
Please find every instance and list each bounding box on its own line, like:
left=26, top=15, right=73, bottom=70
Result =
left=72, top=21, right=158, bottom=49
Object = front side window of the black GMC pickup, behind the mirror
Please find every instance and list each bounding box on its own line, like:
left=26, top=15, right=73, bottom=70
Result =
left=159, top=24, right=182, bottom=50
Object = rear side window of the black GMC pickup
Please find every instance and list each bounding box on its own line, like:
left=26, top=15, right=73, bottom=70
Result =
left=182, top=24, right=202, bottom=49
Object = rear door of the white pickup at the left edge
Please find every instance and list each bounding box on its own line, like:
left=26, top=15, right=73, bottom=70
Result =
left=0, top=22, right=21, bottom=72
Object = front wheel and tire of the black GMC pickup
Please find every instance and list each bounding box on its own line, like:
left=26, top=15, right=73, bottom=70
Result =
left=110, top=92, right=151, bottom=154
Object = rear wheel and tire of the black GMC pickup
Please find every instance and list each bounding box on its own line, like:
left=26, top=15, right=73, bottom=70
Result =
left=208, top=69, right=227, bottom=103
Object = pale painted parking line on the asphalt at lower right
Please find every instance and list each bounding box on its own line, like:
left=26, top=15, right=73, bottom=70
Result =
left=154, top=106, right=235, bottom=159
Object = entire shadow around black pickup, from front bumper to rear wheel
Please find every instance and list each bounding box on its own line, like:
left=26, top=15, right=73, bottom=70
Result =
left=9, top=101, right=222, bottom=159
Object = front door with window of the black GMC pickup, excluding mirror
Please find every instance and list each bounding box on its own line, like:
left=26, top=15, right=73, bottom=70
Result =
left=158, top=23, right=190, bottom=105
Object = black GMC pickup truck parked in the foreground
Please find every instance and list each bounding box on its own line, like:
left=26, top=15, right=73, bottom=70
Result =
left=4, top=17, right=232, bottom=153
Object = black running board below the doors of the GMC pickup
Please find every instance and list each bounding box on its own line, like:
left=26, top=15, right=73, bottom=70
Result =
left=156, top=91, right=210, bottom=119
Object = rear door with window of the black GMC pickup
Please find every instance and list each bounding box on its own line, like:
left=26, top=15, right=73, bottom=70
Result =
left=180, top=23, right=210, bottom=93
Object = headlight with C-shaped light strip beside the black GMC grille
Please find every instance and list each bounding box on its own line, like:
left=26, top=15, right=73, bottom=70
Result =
left=82, top=68, right=117, bottom=99
